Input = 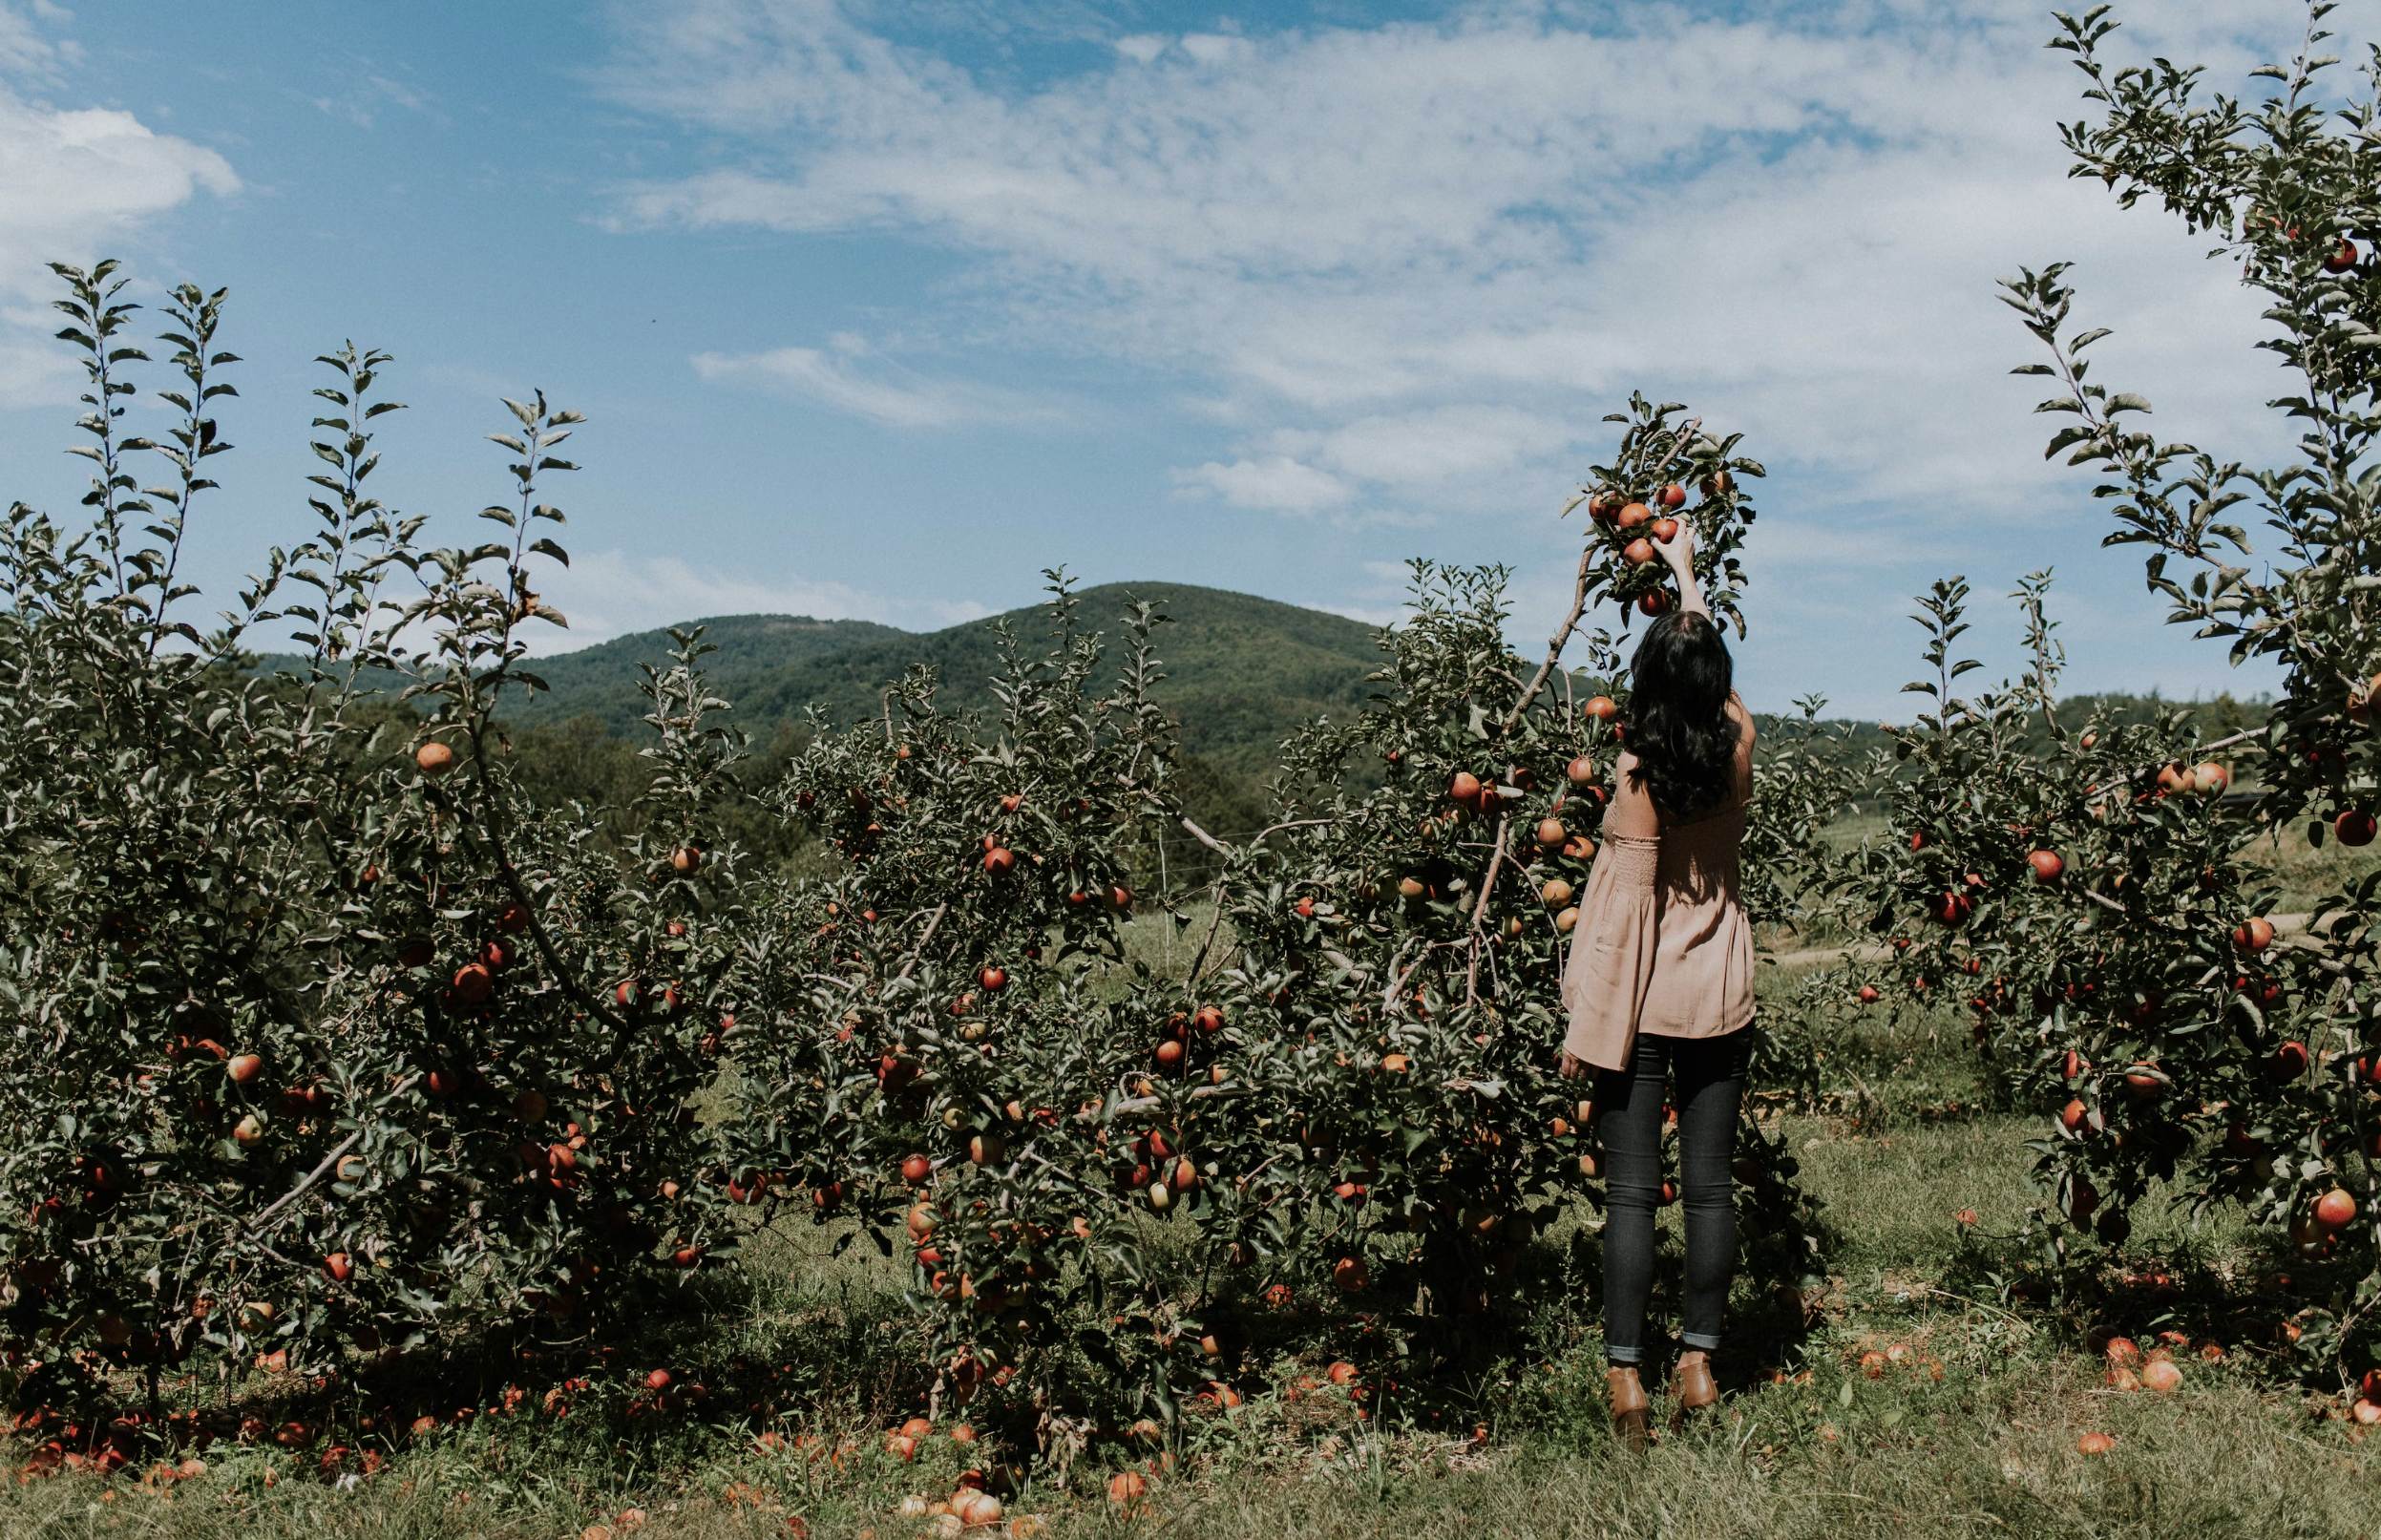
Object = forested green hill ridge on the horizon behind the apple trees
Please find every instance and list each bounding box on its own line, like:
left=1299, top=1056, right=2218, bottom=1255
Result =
left=499, top=583, right=1383, bottom=776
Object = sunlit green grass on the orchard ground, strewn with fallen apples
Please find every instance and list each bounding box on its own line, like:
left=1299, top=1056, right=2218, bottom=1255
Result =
left=0, top=971, right=2381, bottom=1540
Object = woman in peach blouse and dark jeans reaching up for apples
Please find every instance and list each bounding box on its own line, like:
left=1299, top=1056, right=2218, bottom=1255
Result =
left=1562, top=523, right=1753, bottom=1449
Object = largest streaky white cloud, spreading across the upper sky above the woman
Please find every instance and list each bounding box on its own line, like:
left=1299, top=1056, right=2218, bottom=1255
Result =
left=609, top=0, right=2314, bottom=533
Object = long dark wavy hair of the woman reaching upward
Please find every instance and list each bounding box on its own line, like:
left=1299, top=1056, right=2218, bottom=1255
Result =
left=1629, top=609, right=1743, bottom=816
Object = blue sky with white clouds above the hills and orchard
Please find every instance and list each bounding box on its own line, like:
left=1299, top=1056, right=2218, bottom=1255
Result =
left=0, top=0, right=2324, bottom=716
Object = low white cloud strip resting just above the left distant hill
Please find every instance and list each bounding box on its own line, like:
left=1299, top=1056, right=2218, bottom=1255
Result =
left=529, top=550, right=993, bottom=652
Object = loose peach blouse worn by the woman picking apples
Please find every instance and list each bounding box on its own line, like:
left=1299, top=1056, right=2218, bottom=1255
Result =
left=1562, top=802, right=1753, bottom=1068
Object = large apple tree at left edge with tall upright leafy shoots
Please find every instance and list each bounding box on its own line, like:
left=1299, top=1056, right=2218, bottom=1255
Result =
left=0, top=264, right=736, bottom=1397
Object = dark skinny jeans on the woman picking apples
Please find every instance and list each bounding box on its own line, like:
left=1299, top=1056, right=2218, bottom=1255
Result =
left=1595, top=1026, right=1753, bottom=1364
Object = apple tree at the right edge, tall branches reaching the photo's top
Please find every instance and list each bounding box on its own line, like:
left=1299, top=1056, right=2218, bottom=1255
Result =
left=1881, top=2, right=2381, bottom=1357
